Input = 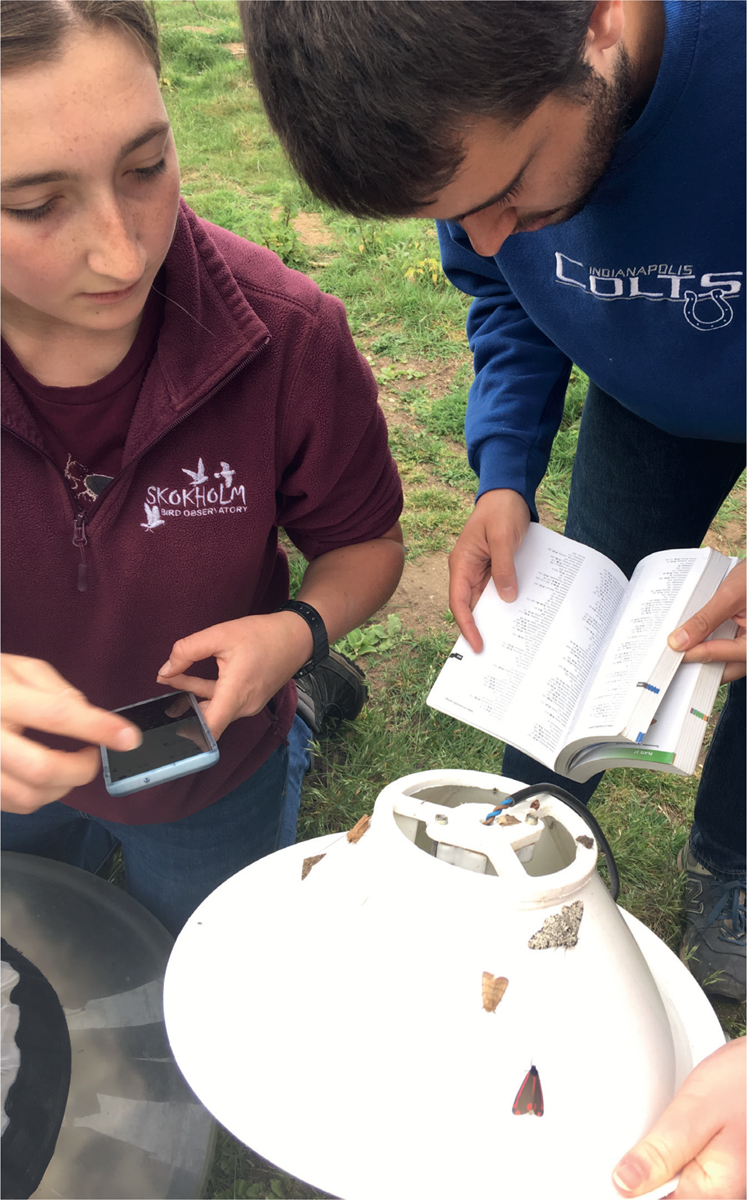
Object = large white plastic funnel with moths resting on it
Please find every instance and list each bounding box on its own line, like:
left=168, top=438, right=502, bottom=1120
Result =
left=165, top=770, right=724, bottom=1200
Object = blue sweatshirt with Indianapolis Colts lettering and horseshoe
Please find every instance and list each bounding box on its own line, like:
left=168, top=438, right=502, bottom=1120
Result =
left=438, top=0, right=745, bottom=515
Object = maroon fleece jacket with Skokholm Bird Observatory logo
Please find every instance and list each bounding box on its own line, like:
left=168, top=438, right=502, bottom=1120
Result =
left=2, top=203, right=402, bottom=824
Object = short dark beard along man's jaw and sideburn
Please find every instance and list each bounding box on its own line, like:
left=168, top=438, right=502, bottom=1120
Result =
left=514, top=46, right=633, bottom=233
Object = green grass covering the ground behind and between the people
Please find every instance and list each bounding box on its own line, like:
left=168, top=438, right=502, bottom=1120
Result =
left=149, top=7, right=745, bottom=1200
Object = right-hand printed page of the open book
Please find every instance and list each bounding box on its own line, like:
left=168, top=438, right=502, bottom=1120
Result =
left=575, top=550, right=710, bottom=738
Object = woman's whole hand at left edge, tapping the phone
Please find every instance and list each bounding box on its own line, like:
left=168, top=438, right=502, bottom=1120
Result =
left=0, top=654, right=142, bottom=812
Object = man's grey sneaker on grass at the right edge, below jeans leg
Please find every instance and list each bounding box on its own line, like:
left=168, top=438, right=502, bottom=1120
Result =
left=677, top=842, right=745, bottom=1001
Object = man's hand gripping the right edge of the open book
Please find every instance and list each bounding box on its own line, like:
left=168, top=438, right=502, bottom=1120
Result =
left=669, top=562, right=747, bottom=683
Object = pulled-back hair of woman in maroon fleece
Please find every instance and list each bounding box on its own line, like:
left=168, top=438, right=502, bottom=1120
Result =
left=0, top=0, right=161, bottom=76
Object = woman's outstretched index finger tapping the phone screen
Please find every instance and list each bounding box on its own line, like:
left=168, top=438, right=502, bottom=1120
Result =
left=2, top=655, right=142, bottom=750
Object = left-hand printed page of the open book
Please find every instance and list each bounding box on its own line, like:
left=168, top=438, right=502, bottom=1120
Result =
left=428, top=523, right=627, bottom=766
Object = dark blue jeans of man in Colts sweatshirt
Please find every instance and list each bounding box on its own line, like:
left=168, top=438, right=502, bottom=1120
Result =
left=502, top=383, right=746, bottom=880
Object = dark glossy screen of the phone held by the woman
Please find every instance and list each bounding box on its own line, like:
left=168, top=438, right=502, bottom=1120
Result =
left=107, top=695, right=210, bottom=784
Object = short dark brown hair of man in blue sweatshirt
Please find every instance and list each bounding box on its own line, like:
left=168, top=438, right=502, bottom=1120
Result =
left=239, top=0, right=594, bottom=216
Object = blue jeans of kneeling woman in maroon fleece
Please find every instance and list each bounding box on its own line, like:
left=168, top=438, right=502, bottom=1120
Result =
left=2, top=716, right=311, bottom=937
